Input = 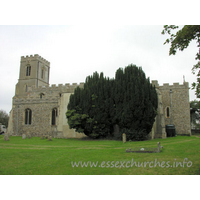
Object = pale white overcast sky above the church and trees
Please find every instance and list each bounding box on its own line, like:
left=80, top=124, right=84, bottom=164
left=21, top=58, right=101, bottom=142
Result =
left=0, top=25, right=198, bottom=113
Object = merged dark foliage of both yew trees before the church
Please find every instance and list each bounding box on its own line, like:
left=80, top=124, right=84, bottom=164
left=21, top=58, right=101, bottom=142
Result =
left=66, top=65, right=157, bottom=138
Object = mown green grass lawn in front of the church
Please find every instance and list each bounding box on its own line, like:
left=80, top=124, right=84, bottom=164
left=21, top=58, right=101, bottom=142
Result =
left=0, top=136, right=200, bottom=175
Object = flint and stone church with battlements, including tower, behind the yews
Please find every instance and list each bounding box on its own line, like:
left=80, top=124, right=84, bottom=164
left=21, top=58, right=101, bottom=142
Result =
left=8, top=54, right=191, bottom=139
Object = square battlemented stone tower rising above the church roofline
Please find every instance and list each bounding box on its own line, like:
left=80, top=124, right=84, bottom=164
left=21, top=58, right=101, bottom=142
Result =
left=15, top=54, right=50, bottom=97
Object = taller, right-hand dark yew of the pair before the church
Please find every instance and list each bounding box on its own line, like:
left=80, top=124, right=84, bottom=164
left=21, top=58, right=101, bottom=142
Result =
left=115, top=65, right=157, bottom=140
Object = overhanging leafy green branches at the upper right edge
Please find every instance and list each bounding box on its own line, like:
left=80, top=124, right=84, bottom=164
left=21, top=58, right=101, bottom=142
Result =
left=162, top=25, right=200, bottom=98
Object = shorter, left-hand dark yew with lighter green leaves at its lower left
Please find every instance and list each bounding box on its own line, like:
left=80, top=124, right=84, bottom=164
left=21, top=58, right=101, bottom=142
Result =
left=66, top=72, right=113, bottom=138
